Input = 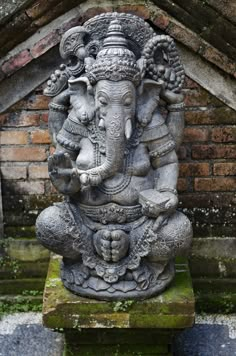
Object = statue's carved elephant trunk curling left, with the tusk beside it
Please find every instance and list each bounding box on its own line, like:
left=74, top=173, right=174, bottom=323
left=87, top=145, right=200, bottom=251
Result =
left=78, top=115, right=131, bottom=186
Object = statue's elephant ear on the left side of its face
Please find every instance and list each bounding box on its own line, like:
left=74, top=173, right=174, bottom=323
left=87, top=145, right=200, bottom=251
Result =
left=68, top=77, right=95, bottom=125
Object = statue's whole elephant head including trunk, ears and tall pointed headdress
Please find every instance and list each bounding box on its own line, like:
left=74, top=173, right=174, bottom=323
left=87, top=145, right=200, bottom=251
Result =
left=66, top=20, right=163, bottom=186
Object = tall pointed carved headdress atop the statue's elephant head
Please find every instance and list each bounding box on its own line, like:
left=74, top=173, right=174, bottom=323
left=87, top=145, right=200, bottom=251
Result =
left=85, top=19, right=141, bottom=85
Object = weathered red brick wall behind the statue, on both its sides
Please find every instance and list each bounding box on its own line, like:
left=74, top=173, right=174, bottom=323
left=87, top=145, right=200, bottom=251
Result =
left=0, top=79, right=236, bottom=238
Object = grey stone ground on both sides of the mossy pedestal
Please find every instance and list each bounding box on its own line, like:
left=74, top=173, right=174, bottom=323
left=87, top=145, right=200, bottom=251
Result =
left=0, top=313, right=236, bottom=356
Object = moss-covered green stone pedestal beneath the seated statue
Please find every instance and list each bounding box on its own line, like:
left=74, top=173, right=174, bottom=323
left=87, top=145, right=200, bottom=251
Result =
left=43, top=255, right=194, bottom=356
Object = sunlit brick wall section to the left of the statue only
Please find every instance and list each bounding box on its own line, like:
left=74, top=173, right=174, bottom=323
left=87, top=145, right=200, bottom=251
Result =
left=0, top=87, right=63, bottom=238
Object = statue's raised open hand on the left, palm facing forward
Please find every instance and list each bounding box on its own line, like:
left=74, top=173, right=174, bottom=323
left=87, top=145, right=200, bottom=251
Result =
left=48, top=152, right=80, bottom=194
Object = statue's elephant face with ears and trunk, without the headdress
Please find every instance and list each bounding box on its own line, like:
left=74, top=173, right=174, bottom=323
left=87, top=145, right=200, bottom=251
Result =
left=69, top=77, right=162, bottom=186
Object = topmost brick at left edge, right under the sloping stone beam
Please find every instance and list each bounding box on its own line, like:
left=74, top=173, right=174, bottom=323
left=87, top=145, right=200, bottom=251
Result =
left=3, top=111, right=40, bottom=127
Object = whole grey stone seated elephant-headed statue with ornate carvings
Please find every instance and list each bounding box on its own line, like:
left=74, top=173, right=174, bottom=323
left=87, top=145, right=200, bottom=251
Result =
left=36, top=13, right=192, bottom=300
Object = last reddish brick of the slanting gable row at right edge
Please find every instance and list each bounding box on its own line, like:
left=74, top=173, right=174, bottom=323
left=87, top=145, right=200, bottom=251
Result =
left=203, top=47, right=236, bottom=74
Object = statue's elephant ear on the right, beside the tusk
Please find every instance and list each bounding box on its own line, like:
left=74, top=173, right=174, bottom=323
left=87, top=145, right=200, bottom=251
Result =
left=136, top=79, right=164, bottom=126
